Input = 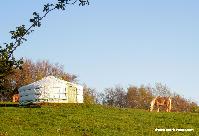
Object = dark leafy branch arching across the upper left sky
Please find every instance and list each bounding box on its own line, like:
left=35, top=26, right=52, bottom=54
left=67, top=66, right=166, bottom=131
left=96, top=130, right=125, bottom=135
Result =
left=0, top=0, right=89, bottom=85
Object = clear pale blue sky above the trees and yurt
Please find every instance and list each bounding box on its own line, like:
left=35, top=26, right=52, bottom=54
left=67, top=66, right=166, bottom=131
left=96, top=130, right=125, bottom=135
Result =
left=0, top=0, right=199, bottom=104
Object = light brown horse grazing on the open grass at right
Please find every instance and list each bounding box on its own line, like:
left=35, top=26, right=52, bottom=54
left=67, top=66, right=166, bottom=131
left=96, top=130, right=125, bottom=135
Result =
left=150, top=96, right=171, bottom=112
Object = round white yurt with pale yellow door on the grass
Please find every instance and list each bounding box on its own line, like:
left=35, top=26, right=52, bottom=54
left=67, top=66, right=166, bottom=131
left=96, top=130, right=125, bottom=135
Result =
left=18, top=76, right=83, bottom=105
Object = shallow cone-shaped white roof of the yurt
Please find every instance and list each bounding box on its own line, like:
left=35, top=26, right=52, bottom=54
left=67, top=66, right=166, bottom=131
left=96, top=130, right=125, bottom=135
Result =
left=19, top=76, right=66, bottom=90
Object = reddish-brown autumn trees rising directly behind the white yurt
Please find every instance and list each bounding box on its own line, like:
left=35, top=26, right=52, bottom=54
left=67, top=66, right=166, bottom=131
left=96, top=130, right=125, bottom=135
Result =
left=4, top=60, right=77, bottom=97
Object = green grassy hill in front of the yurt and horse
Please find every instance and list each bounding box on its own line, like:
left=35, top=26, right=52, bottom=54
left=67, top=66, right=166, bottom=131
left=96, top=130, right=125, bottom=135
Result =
left=0, top=104, right=199, bottom=136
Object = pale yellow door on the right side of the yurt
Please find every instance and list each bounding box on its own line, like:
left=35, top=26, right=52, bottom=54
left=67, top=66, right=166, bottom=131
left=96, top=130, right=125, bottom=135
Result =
left=68, top=86, right=77, bottom=103
